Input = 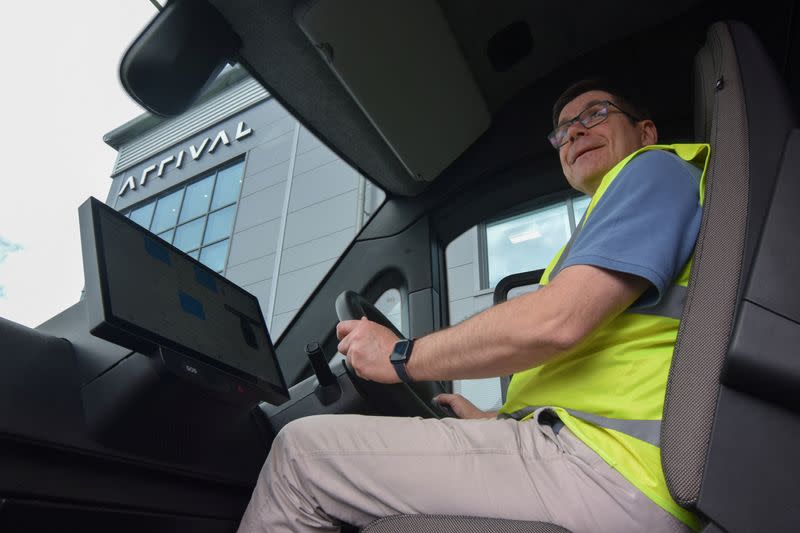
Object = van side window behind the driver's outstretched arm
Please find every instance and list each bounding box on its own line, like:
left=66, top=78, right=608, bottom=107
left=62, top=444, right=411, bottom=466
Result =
left=446, top=195, right=590, bottom=410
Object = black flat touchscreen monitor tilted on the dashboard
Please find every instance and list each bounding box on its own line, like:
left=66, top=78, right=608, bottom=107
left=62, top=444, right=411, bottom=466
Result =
left=79, top=198, right=288, bottom=404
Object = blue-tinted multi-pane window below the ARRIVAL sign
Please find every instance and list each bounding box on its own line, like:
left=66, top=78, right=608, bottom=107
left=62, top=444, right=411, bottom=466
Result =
left=124, top=160, right=244, bottom=272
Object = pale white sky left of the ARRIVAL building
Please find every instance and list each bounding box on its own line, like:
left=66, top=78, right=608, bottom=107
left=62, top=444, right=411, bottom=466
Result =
left=0, top=0, right=158, bottom=327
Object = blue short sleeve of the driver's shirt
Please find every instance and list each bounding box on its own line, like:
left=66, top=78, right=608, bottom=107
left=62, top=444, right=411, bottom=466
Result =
left=562, top=150, right=702, bottom=307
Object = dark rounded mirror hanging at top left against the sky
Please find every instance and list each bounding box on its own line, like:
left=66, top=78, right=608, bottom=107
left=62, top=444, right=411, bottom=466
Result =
left=119, top=0, right=242, bottom=116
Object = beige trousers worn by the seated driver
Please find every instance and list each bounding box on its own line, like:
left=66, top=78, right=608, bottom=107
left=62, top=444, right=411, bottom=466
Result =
left=239, top=413, right=687, bottom=533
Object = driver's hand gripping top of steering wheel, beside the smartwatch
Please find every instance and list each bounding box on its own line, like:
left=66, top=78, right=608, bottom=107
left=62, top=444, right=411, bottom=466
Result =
left=336, top=317, right=400, bottom=384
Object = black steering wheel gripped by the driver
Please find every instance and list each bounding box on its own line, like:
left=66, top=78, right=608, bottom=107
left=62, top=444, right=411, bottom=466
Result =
left=336, top=291, right=447, bottom=417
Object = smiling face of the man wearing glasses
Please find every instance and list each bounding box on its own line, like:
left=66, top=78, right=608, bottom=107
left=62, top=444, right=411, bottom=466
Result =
left=558, top=91, right=657, bottom=196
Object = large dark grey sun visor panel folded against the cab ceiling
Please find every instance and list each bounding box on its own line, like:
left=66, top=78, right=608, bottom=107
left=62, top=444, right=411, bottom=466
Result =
left=296, top=0, right=490, bottom=181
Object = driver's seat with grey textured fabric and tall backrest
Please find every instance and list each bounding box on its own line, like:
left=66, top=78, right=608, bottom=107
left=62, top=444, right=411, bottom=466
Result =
left=361, top=22, right=800, bottom=533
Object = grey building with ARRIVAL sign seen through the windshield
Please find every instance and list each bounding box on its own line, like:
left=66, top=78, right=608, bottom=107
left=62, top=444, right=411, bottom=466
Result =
left=106, top=67, right=385, bottom=366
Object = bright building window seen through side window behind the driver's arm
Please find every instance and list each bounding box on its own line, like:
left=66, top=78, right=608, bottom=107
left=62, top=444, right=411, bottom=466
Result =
left=479, top=196, right=591, bottom=289
